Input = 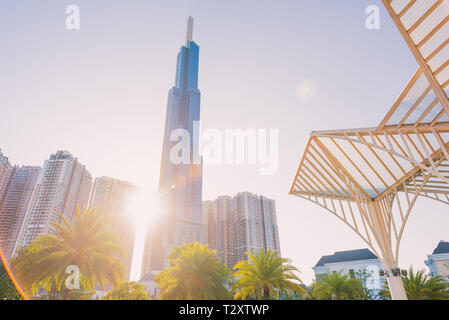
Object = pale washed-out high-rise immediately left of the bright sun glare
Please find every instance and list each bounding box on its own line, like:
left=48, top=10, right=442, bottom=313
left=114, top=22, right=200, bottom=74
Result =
left=89, top=177, right=136, bottom=281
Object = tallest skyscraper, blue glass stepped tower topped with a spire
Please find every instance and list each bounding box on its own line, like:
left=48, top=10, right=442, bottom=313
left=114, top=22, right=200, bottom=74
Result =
left=142, top=17, right=204, bottom=274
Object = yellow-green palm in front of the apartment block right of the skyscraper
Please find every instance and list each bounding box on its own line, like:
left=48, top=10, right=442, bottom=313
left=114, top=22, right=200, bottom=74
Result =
left=234, top=248, right=305, bottom=300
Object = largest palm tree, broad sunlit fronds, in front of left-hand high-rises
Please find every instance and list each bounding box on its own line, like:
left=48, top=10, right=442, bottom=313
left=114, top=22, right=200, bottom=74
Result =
left=11, top=208, right=124, bottom=299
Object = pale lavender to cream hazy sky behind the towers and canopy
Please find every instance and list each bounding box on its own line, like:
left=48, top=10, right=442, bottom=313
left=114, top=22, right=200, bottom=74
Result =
left=0, top=0, right=449, bottom=283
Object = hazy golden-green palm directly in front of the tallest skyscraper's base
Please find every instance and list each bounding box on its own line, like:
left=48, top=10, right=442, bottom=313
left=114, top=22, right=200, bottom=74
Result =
left=155, top=242, right=230, bottom=300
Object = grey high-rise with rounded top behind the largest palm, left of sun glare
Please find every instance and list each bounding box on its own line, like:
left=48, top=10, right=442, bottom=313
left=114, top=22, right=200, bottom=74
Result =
left=14, top=151, right=92, bottom=250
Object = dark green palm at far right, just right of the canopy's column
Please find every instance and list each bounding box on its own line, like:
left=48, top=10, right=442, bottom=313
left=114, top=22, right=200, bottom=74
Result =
left=382, top=268, right=449, bottom=300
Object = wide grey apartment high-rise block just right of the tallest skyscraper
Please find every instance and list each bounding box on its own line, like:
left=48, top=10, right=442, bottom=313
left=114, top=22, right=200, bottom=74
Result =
left=203, top=192, right=280, bottom=269
